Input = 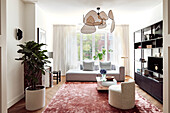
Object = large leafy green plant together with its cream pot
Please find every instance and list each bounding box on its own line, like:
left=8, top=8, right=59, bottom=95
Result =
left=16, top=41, right=50, bottom=110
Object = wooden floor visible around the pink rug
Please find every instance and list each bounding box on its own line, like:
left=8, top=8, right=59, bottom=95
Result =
left=8, top=76, right=163, bottom=113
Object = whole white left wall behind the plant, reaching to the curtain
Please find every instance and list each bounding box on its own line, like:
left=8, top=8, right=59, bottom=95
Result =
left=7, top=0, right=53, bottom=108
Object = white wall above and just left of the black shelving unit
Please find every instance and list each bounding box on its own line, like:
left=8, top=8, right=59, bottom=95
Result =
left=129, top=3, right=163, bottom=78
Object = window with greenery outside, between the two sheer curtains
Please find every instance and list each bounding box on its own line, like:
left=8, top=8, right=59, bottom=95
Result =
left=77, top=32, right=113, bottom=61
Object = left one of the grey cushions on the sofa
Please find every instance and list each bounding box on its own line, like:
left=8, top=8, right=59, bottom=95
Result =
left=83, top=61, right=94, bottom=71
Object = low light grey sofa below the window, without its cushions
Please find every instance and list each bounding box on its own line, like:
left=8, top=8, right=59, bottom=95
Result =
left=66, top=67, right=125, bottom=82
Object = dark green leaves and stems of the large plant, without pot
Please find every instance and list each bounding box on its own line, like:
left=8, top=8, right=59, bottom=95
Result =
left=16, top=41, right=50, bottom=90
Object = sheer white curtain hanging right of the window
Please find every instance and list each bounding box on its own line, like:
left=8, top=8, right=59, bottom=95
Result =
left=113, top=25, right=130, bottom=75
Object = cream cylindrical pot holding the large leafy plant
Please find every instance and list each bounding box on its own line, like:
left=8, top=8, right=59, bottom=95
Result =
left=25, top=86, right=45, bottom=111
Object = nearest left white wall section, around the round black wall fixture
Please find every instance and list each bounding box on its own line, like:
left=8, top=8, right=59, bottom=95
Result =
left=7, top=0, right=25, bottom=108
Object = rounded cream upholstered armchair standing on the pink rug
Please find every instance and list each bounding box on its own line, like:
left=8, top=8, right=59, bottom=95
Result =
left=109, top=80, right=135, bottom=109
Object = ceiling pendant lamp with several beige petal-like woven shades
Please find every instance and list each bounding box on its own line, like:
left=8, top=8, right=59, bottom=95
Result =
left=81, top=7, right=115, bottom=34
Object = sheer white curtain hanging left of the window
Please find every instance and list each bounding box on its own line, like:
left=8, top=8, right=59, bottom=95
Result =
left=53, top=25, right=78, bottom=75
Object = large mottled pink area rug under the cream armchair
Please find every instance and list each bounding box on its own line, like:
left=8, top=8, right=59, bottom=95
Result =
left=43, top=82, right=162, bottom=113
